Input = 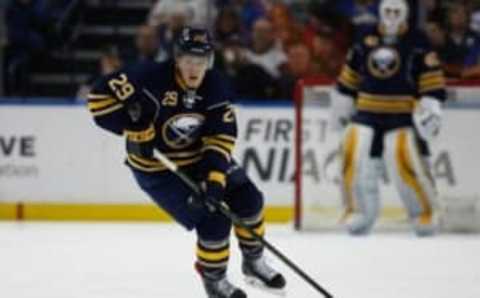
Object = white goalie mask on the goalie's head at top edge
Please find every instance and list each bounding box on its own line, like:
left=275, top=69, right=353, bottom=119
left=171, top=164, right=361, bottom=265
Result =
left=380, top=0, right=408, bottom=37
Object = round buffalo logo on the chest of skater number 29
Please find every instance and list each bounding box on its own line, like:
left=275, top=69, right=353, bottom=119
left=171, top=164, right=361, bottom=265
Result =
left=162, top=113, right=204, bottom=149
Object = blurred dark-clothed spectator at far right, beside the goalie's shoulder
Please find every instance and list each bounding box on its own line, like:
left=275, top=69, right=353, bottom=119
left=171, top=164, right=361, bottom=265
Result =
left=443, top=4, right=477, bottom=77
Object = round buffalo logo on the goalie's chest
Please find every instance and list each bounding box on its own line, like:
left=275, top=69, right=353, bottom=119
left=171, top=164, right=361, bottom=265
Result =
left=368, top=47, right=400, bottom=79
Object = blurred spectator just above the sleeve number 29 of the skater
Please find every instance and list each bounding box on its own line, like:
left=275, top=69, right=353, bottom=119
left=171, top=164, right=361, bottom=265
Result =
left=77, top=46, right=122, bottom=100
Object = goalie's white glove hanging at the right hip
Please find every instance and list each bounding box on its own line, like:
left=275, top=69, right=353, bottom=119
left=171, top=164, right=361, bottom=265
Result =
left=413, top=96, right=443, bottom=141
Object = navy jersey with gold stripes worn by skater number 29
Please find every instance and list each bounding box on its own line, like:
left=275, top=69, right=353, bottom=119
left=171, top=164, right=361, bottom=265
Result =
left=88, top=61, right=237, bottom=177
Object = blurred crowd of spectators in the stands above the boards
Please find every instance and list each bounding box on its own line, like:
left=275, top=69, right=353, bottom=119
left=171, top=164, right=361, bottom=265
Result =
left=4, top=0, right=480, bottom=99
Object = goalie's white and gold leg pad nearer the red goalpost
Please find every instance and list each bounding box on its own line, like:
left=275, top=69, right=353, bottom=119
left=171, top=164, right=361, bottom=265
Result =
left=342, top=123, right=379, bottom=235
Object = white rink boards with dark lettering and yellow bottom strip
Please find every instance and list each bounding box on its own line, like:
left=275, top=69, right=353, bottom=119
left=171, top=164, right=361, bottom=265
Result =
left=0, top=99, right=480, bottom=221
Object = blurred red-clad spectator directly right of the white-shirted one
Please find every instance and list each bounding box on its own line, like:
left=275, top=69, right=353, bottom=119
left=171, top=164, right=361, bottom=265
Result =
left=279, top=43, right=314, bottom=99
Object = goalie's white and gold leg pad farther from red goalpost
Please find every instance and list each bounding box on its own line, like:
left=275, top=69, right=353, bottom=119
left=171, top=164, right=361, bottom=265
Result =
left=384, top=128, right=438, bottom=236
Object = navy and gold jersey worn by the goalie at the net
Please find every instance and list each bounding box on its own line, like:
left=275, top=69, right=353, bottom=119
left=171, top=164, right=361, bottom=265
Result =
left=337, top=28, right=446, bottom=128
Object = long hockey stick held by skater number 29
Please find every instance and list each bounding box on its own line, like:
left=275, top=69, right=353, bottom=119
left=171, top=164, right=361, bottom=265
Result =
left=154, top=150, right=333, bottom=298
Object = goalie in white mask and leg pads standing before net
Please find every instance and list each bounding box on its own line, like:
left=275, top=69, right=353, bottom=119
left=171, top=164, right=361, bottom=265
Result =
left=337, top=0, right=446, bottom=235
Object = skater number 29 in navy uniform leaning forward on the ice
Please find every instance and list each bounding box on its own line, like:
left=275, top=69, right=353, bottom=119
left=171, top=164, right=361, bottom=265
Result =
left=88, top=28, right=285, bottom=298
